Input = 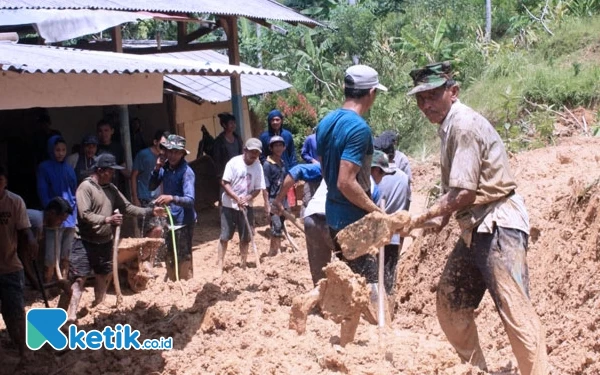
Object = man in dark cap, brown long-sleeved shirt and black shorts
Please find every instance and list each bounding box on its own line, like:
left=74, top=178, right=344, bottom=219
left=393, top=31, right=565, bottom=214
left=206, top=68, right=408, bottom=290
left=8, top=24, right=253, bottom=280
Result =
left=60, top=153, right=165, bottom=322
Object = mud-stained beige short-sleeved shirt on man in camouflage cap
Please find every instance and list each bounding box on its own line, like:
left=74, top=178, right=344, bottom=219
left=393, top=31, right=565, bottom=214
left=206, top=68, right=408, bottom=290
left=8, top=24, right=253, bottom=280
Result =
left=438, top=100, right=529, bottom=238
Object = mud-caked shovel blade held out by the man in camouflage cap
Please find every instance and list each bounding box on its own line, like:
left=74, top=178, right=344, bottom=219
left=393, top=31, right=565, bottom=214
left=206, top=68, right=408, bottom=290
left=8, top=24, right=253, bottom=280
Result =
left=336, top=211, right=410, bottom=260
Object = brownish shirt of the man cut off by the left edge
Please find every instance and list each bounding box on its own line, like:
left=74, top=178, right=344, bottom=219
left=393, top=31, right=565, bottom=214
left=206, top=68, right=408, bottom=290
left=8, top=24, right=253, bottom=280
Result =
left=0, top=190, right=31, bottom=275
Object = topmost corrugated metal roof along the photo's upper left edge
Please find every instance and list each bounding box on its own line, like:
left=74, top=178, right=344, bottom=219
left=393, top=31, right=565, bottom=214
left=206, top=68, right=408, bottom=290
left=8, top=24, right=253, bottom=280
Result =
left=0, top=0, right=321, bottom=26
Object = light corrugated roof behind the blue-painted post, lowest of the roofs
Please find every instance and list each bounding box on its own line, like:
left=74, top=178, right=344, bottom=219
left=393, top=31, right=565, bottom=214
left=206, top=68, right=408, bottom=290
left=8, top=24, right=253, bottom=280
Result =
left=158, top=51, right=292, bottom=102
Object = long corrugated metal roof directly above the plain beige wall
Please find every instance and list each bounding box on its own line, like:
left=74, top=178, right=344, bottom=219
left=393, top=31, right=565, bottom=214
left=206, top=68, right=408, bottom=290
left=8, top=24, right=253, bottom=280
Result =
left=0, top=42, right=285, bottom=76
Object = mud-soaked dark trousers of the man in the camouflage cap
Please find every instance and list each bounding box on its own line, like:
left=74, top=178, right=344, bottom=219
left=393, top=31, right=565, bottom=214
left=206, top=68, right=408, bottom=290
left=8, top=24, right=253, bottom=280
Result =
left=437, top=227, right=548, bottom=375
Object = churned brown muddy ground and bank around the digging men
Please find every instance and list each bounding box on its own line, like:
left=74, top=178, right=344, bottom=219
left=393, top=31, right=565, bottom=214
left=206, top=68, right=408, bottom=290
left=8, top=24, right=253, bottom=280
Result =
left=0, top=138, right=600, bottom=375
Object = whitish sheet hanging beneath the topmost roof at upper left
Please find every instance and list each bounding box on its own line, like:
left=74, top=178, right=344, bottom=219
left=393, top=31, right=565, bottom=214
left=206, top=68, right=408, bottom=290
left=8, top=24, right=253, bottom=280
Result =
left=0, top=9, right=152, bottom=43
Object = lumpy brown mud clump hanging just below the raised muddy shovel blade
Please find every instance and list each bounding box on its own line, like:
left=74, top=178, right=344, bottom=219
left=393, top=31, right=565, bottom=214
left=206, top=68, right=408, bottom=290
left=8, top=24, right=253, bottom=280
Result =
left=289, top=262, right=369, bottom=346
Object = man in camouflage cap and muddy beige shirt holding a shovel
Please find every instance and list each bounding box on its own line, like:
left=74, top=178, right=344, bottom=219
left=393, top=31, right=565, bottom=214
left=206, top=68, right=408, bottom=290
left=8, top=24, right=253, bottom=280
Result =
left=408, top=62, right=548, bottom=375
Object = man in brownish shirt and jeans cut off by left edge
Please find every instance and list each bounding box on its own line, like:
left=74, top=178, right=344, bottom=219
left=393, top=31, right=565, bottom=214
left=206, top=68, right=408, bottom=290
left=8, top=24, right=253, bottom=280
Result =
left=0, top=166, right=38, bottom=358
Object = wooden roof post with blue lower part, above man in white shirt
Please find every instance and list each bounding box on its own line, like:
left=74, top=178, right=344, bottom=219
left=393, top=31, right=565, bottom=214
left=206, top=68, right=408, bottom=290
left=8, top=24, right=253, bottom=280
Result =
left=221, top=17, right=245, bottom=140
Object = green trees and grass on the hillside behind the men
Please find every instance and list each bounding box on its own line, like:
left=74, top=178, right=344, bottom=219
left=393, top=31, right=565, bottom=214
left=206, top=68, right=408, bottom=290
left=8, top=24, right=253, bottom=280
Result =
left=240, top=0, right=600, bottom=157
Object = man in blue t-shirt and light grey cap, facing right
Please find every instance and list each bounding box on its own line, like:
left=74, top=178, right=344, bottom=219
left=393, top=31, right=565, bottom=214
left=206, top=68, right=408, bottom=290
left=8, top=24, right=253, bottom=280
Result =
left=317, top=65, right=387, bottom=323
